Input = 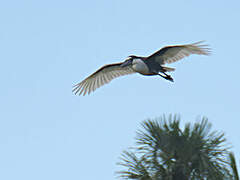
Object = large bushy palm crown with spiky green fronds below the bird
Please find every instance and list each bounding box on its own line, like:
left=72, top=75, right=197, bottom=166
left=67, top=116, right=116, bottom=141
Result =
left=118, top=115, right=232, bottom=180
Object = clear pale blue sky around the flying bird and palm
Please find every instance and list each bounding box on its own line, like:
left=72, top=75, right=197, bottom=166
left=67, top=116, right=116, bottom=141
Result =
left=0, top=0, right=240, bottom=180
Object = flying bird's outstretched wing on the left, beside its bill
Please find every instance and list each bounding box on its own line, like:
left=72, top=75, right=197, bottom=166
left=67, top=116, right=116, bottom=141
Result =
left=72, top=63, right=135, bottom=96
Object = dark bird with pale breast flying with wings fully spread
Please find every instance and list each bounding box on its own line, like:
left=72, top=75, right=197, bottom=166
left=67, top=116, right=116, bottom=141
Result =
left=72, top=41, right=210, bottom=96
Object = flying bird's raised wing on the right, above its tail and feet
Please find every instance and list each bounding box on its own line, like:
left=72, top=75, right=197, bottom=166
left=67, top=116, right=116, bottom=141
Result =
left=147, top=41, right=210, bottom=65
